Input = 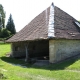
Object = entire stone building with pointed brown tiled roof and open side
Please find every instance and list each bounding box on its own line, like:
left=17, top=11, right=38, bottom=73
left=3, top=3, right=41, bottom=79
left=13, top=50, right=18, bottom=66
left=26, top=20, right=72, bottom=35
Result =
left=7, top=3, right=80, bottom=63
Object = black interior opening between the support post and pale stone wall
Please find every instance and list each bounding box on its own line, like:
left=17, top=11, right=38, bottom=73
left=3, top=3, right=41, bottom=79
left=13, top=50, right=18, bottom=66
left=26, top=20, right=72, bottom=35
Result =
left=28, top=40, right=49, bottom=60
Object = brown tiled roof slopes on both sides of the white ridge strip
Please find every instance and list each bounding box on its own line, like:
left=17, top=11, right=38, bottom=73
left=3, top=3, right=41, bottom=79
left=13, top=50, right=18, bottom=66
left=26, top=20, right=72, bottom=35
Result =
left=7, top=6, right=80, bottom=42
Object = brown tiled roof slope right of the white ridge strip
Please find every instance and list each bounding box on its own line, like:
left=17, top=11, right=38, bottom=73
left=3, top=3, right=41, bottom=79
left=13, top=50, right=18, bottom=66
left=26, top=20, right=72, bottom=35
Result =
left=54, top=7, right=80, bottom=39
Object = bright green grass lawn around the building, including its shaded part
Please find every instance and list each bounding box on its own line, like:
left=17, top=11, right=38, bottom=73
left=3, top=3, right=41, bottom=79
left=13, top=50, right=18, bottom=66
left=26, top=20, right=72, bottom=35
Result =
left=0, top=43, right=80, bottom=80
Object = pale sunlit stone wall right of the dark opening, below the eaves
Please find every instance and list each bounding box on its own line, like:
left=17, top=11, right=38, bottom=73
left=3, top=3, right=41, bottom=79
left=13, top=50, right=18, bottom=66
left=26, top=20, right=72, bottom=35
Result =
left=49, top=40, right=80, bottom=63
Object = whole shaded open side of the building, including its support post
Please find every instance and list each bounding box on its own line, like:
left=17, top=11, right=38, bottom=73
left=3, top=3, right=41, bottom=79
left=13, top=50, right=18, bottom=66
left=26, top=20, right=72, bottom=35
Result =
left=12, top=40, right=49, bottom=59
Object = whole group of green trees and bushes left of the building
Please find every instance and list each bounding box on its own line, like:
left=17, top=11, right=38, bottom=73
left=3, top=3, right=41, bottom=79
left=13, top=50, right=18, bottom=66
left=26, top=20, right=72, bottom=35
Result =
left=0, top=4, right=16, bottom=38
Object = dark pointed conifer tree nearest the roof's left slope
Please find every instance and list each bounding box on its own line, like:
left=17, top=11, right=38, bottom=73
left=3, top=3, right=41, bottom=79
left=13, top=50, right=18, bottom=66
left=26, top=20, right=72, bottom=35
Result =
left=6, top=14, right=16, bottom=34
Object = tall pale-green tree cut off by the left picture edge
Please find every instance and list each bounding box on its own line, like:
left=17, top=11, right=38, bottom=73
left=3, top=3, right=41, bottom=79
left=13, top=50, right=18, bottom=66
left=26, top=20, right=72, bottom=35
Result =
left=0, top=4, right=5, bottom=28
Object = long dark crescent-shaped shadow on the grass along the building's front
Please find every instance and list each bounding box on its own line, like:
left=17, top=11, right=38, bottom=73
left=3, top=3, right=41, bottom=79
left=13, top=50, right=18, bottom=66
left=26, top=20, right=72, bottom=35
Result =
left=1, top=57, right=79, bottom=70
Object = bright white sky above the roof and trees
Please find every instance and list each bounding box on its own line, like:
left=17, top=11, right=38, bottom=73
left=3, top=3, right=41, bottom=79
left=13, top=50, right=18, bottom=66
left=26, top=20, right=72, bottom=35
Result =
left=0, top=0, right=80, bottom=32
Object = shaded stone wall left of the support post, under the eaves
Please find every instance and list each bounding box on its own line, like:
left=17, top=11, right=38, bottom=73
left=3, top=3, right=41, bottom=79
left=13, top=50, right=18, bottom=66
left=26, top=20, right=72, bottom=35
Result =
left=11, top=42, right=26, bottom=57
